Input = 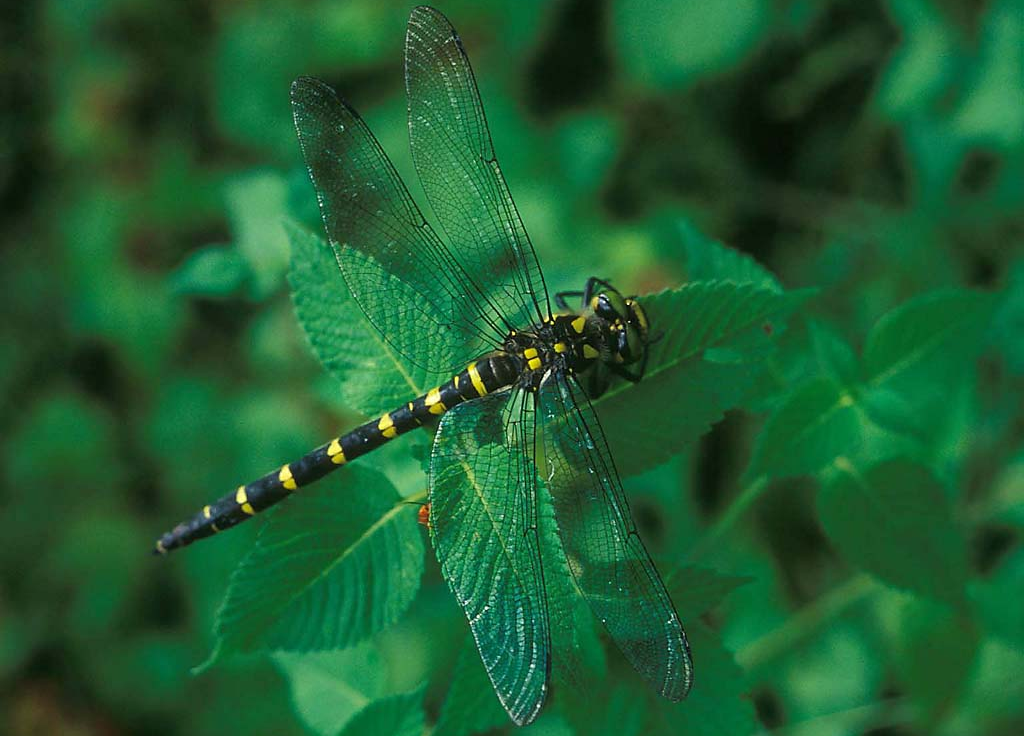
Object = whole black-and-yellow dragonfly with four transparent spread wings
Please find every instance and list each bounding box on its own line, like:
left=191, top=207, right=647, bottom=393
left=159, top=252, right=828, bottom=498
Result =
left=156, top=2, right=693, bottom=725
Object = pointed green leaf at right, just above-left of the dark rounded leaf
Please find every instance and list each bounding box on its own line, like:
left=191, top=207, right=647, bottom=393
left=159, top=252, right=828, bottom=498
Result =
left=748, top=379, right=860, bottom=478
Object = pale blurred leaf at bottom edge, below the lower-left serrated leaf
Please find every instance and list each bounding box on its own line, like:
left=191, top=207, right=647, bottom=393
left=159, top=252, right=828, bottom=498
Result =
left=270, top=642, right=387, bottom=736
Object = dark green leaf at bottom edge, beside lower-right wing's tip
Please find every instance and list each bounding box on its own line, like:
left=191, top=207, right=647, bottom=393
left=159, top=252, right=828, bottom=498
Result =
left=644, top=621, right=757, bottom=736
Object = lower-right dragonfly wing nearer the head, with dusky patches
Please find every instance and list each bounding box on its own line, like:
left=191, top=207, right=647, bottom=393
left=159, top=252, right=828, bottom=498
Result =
left=539, top=374, right=693, bottom=700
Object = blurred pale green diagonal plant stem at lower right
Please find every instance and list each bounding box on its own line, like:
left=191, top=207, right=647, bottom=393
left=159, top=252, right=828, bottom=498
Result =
left=736, top=573, right=878, bottom=674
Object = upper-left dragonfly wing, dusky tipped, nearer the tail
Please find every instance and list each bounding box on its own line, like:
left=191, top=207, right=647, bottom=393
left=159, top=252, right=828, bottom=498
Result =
left=292, top=77, right=505, bottom=374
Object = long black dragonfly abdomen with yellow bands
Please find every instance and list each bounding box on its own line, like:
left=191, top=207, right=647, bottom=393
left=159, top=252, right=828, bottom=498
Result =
left=156, top=353, right=519, bottom=555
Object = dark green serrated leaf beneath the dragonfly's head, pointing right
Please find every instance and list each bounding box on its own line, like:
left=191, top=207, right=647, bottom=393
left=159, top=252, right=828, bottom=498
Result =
left=594, top=282, right=808, bottom=476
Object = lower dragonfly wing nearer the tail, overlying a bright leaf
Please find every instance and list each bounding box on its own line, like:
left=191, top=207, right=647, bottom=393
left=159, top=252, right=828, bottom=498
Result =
left=429, top=389, right=551, bottom=726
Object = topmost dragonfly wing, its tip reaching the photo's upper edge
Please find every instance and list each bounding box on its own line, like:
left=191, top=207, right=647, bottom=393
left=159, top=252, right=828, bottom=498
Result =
left=406, top=7, right=550, bottom=328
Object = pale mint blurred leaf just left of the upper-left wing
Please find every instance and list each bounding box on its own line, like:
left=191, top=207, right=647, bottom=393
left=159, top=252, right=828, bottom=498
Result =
left=226, top=172, right=288, bottom=299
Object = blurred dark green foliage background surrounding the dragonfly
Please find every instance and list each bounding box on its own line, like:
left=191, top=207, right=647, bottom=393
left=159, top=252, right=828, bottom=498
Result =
left=0, top=0, right=1024, bottom=735
